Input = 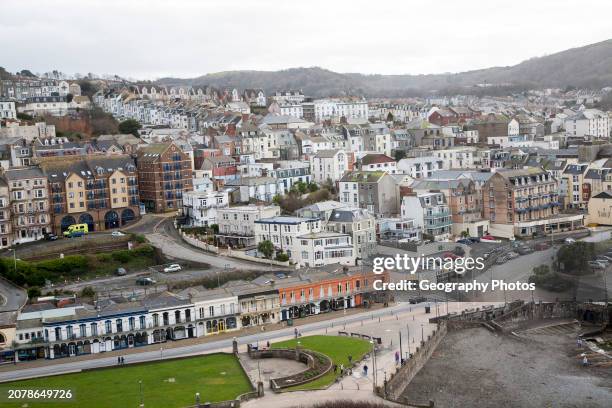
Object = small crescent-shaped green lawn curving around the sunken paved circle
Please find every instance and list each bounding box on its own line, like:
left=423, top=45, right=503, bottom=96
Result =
left=271, top=336, right=372, bottom=391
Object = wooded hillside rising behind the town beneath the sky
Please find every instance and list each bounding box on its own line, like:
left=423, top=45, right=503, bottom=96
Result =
left=157, top=40, right=612, bottom=97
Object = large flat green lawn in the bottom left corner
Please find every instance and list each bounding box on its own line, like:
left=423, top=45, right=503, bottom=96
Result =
left=0, top=354, right=251, bottom=408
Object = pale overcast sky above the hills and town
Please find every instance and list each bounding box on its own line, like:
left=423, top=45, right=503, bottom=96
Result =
left=0, top=0, right=612, bottom=79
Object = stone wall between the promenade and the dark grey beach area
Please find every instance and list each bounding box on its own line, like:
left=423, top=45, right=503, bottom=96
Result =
left=379, top=322, right=448, bottom=402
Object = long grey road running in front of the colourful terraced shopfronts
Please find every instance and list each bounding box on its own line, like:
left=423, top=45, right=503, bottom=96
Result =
left=0, top=303, right=490, bottom=382
